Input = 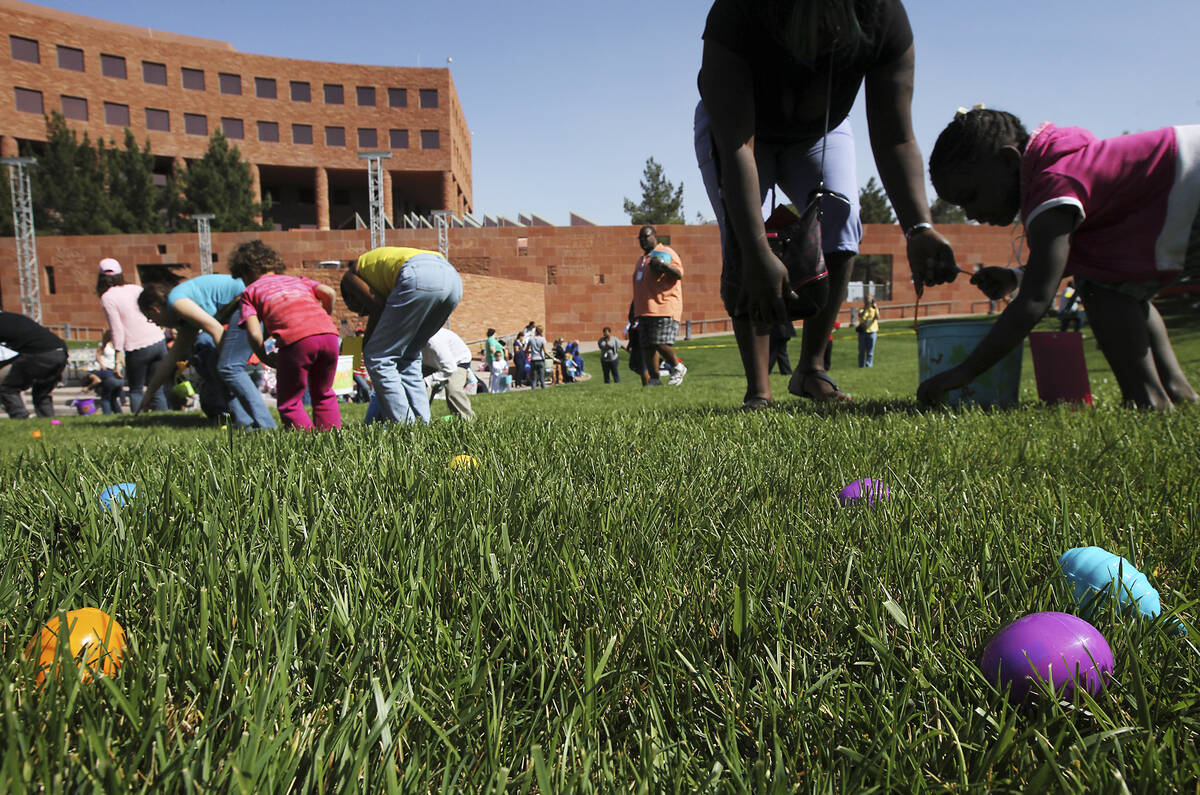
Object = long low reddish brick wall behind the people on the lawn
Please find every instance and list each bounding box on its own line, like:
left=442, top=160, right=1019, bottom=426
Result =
left=0, top=225, right=1013, bottom=341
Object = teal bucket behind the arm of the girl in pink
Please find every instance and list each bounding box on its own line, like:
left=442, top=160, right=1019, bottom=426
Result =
left=917, top=321, right=1025, bottom=406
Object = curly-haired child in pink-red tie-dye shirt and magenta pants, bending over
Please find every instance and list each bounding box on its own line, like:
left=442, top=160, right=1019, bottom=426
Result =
left=229, top=240, right=342, bottom=431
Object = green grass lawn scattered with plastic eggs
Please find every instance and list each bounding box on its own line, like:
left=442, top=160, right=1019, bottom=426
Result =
left=0, top=303, right=1200, bottom=793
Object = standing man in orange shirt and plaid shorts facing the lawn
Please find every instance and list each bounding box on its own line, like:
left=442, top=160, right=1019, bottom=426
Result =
left=632, top=225, right=688, bottom=387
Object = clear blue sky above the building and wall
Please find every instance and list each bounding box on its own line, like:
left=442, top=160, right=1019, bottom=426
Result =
left=32, top=0, right=1200, bottom=225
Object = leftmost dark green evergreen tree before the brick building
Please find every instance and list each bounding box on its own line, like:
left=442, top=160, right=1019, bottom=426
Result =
left=28, top=112, right=118, bottom=234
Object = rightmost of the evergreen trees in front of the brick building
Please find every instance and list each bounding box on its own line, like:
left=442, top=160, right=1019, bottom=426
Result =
left=180, top=130, right=271, bottom=232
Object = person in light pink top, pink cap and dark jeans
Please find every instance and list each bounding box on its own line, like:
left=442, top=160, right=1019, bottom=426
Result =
left=96, top=257, right=167, bottom=412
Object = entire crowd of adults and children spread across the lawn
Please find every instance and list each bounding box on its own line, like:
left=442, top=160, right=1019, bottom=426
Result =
left=0, top=0, right=1200, bottom=417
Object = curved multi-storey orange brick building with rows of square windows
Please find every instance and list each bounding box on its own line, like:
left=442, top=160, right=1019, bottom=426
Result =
left=0, top=0, right=473, bottom=229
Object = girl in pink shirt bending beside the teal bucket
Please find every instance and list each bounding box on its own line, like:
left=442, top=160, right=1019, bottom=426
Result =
left=917, top=107, right=1200, bottom=408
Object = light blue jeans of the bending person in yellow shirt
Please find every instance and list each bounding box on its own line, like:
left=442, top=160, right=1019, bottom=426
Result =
left=362, top=253, right=462, bottom=423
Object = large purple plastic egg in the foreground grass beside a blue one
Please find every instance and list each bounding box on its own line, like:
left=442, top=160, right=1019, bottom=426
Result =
left=979, top=612, right=1114, bottom=701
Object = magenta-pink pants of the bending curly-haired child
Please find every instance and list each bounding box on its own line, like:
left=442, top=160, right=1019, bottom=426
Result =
left=275, top=334, right=342, bottom=431
